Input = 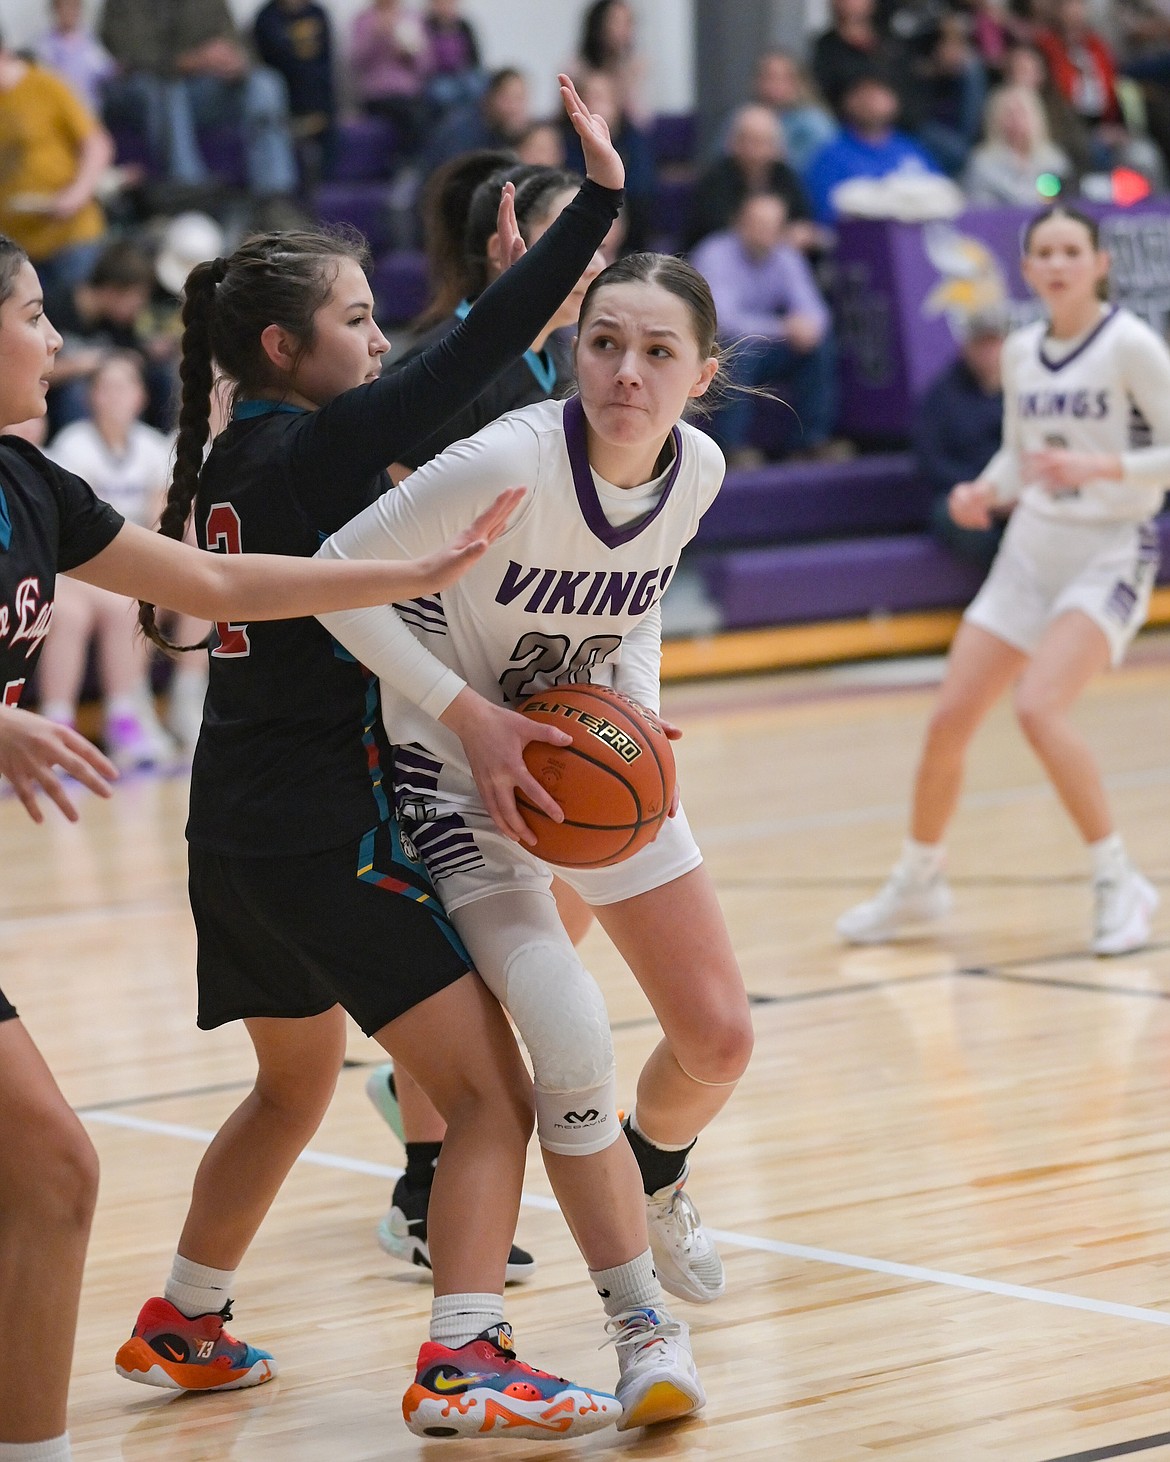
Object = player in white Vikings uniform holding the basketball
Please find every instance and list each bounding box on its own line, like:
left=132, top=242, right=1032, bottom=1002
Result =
left=322, top=254, right=752, bottom=1427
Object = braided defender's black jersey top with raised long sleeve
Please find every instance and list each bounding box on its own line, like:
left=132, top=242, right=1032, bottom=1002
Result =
left=187, top=183, right=622, bottom=857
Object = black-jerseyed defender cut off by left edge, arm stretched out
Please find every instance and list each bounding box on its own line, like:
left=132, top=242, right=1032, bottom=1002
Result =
left=0, top=235, right=513, bottom=1462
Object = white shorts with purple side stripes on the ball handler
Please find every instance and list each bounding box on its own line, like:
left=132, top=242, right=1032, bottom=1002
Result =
left=401, top=807, right=703, bottom=912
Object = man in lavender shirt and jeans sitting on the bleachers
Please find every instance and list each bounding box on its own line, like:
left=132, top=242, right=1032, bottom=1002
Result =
left=690, top=193, right=837, bottom=466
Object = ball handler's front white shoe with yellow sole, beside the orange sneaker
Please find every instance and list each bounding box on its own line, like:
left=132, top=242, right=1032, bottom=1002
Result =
left=605, top=1307, right=706, bottom=1431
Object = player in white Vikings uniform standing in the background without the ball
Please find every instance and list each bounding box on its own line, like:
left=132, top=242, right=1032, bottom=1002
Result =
left=837, top=208, right=1170, bottom=955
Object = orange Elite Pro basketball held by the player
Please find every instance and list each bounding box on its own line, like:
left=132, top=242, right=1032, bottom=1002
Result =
left=516, top=686, right=674, bottom=868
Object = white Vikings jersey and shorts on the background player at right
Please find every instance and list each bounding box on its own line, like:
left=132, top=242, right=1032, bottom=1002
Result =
left=967, top=308, right=1170, bottom=664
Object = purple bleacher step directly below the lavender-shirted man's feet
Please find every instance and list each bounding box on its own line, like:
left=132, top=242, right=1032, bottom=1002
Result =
left=695, top=452, right=930, bottom=547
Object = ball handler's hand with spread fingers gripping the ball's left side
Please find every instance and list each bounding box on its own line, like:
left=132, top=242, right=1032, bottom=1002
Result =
left=439, top=686, right=572, bottom=846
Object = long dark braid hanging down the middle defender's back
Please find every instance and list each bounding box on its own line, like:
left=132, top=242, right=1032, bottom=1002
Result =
left=137, top=259, right=227, bottom=651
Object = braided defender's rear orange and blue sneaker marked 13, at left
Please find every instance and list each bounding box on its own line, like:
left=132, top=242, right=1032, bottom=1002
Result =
left=114, top=1298, right=276, bottom=1390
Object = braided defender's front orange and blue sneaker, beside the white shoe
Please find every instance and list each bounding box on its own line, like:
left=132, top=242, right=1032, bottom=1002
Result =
left=402, top=1325, right=622, bottom=1442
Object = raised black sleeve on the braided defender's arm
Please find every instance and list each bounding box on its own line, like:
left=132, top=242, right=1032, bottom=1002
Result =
left=283, top=180, right=622, bottom=515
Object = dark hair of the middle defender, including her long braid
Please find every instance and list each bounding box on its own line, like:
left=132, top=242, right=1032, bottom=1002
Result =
left=137, top=228, right=369, bottom=651
